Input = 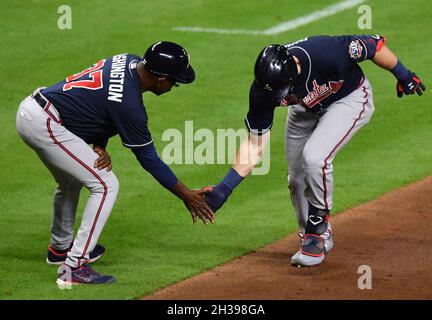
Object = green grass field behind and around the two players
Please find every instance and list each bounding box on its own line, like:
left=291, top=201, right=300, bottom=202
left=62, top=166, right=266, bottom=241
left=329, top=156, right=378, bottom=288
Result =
left=0, top=0, right=432, bottom=299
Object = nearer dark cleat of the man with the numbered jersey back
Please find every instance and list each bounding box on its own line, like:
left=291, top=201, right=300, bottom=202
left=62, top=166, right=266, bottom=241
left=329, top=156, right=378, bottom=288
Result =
left=56, top=264, right=116, bottom=289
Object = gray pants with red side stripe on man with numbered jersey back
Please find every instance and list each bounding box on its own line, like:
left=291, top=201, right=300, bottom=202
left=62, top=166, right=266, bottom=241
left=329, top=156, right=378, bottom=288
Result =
left=16, top=91, right=119, bottom=267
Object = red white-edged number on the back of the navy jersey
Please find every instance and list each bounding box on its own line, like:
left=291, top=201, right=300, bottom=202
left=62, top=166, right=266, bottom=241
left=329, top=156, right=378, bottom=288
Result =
left=63, top=59, right=105, bottom=91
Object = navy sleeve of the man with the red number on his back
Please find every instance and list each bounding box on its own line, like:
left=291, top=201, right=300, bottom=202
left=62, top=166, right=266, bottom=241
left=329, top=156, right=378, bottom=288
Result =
left=109, top=89, right=153, bottom=148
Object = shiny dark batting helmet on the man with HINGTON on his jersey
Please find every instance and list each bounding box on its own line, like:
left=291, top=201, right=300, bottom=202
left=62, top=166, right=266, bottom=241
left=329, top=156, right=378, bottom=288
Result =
left=143, top=41, right=195, bottom=83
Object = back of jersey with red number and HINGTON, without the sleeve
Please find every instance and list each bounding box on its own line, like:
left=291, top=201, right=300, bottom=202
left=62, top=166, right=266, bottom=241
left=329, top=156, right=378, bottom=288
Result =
left=41, top=53, right=142, bottom=143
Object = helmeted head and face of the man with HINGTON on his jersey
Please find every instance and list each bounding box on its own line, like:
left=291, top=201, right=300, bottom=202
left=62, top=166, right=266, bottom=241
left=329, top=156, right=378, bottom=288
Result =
left=137, top=41, right=195, bottom=95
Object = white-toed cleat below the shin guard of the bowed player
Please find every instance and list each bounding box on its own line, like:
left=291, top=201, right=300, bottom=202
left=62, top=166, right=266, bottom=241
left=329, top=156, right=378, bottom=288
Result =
left=291, top=234, right=326, bottom=267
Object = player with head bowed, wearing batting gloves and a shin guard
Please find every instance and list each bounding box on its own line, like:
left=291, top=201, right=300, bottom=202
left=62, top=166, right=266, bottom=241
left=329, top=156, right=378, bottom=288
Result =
left=205, top=35, right=425, bottom=266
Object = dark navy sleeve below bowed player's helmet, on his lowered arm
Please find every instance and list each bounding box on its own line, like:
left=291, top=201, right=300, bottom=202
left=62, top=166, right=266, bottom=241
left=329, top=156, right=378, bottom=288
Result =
left=245, top=82, right=284, bottom=135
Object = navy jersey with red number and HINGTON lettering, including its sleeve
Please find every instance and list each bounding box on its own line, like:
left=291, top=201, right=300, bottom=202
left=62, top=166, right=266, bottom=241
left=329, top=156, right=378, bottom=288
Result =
left=41, top=53, right=152, bottom=147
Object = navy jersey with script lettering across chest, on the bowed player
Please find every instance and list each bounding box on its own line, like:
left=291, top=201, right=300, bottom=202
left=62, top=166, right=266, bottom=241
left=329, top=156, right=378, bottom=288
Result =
left=245, top=35, right=385, bottom=134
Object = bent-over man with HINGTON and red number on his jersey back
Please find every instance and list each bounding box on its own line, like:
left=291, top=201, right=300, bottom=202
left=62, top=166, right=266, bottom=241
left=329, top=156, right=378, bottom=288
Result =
left=16, top=41, right=214, bottom=286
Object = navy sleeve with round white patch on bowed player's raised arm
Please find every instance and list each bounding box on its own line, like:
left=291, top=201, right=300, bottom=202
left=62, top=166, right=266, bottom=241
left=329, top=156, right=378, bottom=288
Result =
left=341, top=35, right=386, bottom=63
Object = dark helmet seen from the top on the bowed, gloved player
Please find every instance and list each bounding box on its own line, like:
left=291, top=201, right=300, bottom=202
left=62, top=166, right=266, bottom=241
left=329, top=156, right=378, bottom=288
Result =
left=254, top=44, right=298, bottom=91
